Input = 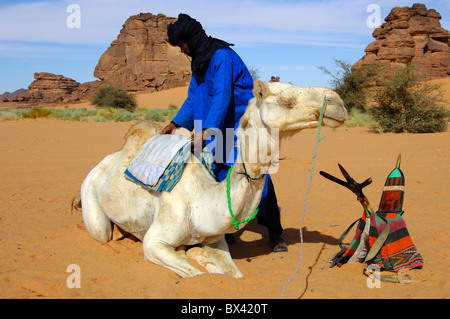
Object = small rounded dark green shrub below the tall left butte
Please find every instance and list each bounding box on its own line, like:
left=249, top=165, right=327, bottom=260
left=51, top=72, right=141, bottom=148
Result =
left=91, top=86, right=136, bottom=111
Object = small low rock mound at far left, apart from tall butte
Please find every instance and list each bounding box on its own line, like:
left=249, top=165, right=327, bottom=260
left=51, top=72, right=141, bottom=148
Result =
left=10, top=72, right=80, bottom=103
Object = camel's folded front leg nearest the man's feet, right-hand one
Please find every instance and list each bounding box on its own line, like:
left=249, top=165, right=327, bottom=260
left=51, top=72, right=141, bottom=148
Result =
left=203, top=235, right=244, bottom=278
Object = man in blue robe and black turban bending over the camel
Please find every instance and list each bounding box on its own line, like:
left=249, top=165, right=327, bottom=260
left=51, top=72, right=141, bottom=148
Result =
left=161, top=13, right=287, bottom=252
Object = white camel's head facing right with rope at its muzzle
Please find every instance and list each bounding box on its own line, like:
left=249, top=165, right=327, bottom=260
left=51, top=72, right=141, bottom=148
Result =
left=253, top=81, right=348, bottom=132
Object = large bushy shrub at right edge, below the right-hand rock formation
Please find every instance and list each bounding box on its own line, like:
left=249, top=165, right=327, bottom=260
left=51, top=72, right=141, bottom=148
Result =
left=370, top=65, right=448, bottom=133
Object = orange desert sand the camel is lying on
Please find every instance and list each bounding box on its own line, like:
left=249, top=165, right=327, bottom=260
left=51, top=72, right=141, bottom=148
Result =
left=0, top=81, right=450, bottom=299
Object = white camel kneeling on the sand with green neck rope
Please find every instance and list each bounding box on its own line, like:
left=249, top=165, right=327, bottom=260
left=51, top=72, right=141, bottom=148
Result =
left=72, top=81, right=347, bottom=277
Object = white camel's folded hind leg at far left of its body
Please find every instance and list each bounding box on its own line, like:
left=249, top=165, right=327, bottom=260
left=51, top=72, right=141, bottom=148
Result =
left=80, top=169, right=113, bottom=243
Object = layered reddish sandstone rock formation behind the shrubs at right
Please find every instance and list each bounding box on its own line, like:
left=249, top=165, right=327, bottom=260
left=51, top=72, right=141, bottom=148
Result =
left=353, top=3, right=450, bottom=79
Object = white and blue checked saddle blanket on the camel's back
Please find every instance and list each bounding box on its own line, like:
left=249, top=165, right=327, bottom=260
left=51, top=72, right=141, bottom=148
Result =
left=124, top=135, right=215, bottom=192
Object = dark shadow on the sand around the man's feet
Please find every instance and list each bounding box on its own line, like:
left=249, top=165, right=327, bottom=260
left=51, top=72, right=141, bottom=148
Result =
left=228, top=221, right=339, bottom=259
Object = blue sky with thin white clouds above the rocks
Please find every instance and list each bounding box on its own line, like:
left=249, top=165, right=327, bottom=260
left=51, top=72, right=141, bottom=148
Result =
left=0, top=0, right=450, bottom=93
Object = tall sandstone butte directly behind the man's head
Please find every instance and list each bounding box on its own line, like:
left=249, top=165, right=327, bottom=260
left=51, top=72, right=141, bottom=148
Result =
left=94, top=13, right=191, bottom=91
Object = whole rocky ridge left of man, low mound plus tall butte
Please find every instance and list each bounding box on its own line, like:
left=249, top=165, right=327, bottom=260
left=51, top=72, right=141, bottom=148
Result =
left=0, top=13, right=191, bottom=104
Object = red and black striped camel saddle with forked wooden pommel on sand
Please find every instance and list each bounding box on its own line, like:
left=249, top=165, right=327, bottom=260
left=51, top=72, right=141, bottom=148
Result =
left=320, top=155, right=423, bottom=282
